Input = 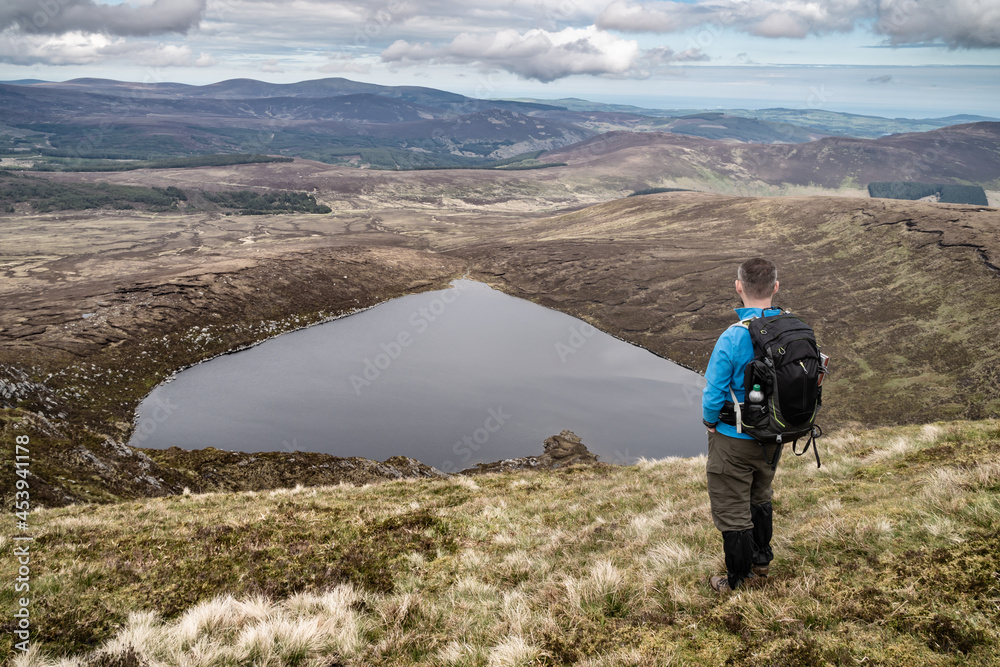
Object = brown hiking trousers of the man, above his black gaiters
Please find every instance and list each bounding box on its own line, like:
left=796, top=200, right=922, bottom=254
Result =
left=706, top=431, right=776, bottom=532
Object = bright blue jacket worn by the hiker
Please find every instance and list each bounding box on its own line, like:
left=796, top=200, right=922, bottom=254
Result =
left=701, top=308, right=781, bottom=440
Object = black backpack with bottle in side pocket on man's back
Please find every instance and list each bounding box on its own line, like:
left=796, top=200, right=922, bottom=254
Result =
left=727, top=312, right=829, bottom=467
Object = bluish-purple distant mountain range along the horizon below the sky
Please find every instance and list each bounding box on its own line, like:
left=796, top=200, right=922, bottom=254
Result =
left=0, top=78, right=993, bottom=171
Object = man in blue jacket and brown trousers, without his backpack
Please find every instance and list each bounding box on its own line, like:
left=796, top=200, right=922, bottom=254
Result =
left=702, top=258, right=780, bottom=592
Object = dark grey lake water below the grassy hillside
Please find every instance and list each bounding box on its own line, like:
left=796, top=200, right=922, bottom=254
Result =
left=130, top=280, right=705, bottom=471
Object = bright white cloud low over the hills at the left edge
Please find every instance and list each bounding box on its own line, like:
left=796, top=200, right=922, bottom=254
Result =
left=0, top=30, right=216, bottom=67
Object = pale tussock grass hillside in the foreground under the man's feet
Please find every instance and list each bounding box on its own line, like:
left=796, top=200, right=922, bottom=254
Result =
left=0, top=421, right=1000, bottom=667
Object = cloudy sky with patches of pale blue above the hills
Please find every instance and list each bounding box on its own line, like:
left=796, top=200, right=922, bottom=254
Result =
left=0, top=0, right=1000, bottom=117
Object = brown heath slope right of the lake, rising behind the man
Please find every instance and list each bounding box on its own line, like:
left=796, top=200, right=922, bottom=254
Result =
left=448, top=192, right=1000, bottom=424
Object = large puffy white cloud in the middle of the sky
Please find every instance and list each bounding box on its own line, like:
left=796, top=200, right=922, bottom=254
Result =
left=382, top=26, right=704, bottom=82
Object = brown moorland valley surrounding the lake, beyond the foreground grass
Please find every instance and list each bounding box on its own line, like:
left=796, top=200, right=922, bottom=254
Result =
left=0, top=154, right=1000, bottom=504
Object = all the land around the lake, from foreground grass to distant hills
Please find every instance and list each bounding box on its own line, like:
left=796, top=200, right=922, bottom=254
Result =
left=0, top=79, right=1000, bottom=667
